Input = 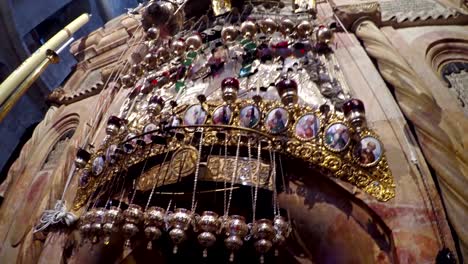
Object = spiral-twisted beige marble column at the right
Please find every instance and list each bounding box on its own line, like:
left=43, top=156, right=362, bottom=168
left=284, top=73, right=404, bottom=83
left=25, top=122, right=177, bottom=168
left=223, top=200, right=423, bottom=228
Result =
left=354, top=20, right=468, bottom=258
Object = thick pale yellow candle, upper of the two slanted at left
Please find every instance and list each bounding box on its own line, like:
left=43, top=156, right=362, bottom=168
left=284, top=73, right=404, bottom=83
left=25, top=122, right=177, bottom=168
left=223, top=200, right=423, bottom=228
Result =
left=0, top=13, right=90, bottom=105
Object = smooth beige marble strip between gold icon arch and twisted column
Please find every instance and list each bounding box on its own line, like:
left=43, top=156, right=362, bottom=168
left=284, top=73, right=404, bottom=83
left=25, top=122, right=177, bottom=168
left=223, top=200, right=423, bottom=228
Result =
left=330, top=31, right=454, bottom=263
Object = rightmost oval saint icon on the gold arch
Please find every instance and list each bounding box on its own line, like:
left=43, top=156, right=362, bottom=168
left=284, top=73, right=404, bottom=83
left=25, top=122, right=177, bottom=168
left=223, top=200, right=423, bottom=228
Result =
left=354, top=136, right=382, bottom=166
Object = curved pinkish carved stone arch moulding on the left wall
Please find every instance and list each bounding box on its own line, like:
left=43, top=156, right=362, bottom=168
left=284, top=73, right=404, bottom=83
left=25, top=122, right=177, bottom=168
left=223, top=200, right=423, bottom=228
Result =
left=9, top=113, right=79, bottom=263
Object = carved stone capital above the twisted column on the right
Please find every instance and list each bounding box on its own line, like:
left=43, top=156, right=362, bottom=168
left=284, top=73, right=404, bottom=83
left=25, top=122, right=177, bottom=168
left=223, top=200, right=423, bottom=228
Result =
left=331, top=0, right=382, bottom=31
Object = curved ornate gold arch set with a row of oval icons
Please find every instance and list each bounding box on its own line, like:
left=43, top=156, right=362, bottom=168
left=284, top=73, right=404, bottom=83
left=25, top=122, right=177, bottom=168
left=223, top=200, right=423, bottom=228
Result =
left=75, top=97, right=395, bottom=208
